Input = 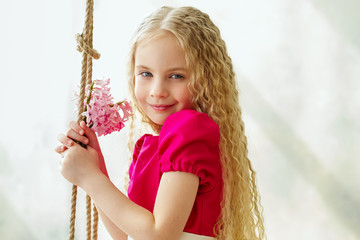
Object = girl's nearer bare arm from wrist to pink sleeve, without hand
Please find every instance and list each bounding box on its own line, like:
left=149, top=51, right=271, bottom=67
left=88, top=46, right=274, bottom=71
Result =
left=81, top=172, right=199, bottom=240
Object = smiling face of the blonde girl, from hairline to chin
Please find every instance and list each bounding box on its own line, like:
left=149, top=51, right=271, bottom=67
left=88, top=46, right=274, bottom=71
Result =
left=135, top=31, right=192, bottom=125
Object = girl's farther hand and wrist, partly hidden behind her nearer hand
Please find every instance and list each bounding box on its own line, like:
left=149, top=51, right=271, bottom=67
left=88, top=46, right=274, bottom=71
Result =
left=55, top=121, right=108, bottom=177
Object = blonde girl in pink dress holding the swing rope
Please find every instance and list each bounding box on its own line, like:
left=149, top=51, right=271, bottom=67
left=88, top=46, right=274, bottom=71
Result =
left=56, top=7, right=264, bottom=240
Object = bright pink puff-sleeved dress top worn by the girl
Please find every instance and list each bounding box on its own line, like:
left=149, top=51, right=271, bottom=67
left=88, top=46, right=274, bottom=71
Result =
left=128, top=110, right=223, bottom=237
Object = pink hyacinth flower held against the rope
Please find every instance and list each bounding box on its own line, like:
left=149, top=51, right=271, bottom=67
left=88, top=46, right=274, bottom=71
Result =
left=77, top=79, right=133, bottom=136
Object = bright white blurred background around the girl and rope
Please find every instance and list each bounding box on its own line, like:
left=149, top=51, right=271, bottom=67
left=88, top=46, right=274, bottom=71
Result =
left=0, top=0, right=360, bottom=240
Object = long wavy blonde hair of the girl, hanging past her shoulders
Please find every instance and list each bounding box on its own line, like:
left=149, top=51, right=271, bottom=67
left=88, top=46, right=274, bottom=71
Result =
left=128, top=7, right=265, bottom=240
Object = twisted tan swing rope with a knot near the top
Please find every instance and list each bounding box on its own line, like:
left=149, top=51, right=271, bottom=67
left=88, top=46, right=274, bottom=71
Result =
left=69, top=0, right=100, bottom=240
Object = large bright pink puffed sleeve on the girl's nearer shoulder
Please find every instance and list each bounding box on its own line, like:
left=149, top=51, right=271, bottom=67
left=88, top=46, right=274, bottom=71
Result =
left=159, top=109, right=222, bottom=192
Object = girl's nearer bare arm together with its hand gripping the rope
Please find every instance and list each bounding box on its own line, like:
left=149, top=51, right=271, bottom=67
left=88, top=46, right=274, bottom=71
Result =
left=56, top=122, right=199, bottom=240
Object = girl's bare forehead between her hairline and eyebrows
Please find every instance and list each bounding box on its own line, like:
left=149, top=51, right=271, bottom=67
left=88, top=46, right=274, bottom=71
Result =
left=135, top=31, right=186, bottom=67
